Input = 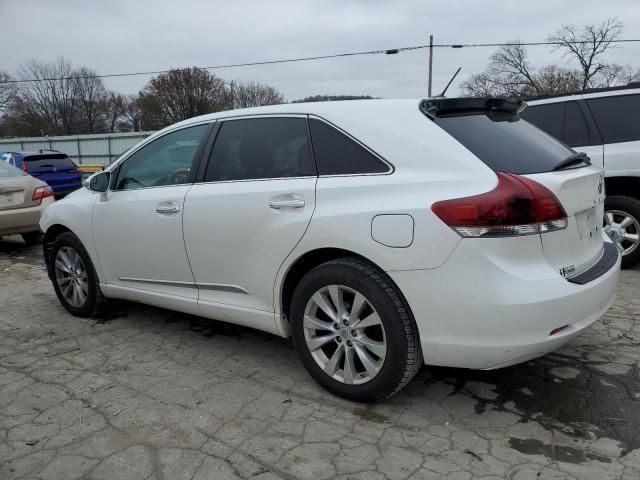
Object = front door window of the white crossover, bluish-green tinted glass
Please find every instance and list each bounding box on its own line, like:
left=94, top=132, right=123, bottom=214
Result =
left=114, top=125, right=209, bottom=190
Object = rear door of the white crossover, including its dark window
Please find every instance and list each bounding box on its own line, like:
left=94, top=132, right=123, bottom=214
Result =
left=184, top=116, right=317, bottom=330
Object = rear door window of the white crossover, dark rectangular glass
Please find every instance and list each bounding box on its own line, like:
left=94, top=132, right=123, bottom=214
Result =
left=205, top=118, right=315, bottom=182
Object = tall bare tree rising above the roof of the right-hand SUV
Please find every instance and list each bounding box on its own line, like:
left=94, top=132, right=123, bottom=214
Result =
left=548, top=18, right=622, bottom=89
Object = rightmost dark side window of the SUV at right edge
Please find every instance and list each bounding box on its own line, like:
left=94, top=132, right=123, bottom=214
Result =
left=587, top=95, right=640, bottom=143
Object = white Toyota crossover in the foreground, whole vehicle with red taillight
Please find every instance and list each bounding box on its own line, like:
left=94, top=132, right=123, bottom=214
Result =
left=41, top=99, right=620, bottom=401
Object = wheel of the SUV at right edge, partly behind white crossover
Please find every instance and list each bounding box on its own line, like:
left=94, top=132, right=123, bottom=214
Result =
left=604, top=195, right=640, bottom=268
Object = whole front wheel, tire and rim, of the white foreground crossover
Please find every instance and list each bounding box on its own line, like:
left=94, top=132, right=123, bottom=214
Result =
left=48, top=232, right=106, bottom=317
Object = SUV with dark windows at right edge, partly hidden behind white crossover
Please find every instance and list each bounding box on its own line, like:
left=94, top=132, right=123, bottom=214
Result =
left=522, top=84, right=640, bottom=268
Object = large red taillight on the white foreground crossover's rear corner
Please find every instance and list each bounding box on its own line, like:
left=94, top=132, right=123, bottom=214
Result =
left=431, top=172, right=567, bottom=237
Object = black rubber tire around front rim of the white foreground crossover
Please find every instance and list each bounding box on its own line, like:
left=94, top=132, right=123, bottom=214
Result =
left=47, top=232, right=106, bottom=317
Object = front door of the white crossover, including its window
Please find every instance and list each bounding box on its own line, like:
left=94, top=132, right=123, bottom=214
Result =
left=93, top=120, right=211, bottom=313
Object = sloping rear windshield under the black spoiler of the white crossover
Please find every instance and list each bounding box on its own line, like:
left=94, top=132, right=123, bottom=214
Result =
left=434, top=112, right=574, bottom=174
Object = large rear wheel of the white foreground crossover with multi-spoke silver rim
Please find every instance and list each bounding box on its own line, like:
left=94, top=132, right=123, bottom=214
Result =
left=291, top=258, right=422, bottom=402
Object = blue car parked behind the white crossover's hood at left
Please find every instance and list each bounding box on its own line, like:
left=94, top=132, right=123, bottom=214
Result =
left=2, top=150, right=82, bottom=198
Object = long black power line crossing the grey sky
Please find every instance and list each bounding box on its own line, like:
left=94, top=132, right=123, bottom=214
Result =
left=0, top=38, right=640, bottom=85
